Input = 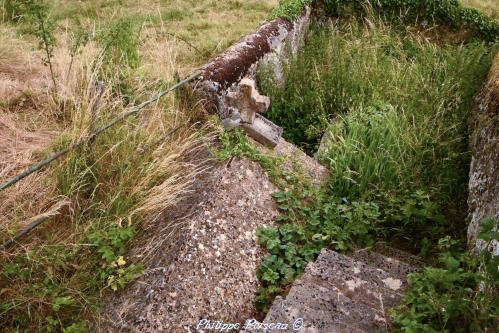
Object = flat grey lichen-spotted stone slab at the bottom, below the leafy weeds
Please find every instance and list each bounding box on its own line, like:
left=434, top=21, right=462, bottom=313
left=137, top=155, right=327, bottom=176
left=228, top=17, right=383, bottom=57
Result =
left=241, top=247, right=421, bottom=333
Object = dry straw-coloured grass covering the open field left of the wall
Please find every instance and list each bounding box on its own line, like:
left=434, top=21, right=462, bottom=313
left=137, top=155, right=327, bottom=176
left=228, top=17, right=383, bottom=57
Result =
left=0, top=0, right=277, bottom=332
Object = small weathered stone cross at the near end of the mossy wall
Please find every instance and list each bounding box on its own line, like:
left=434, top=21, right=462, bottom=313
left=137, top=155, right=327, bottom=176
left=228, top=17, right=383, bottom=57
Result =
left=227, top=78, right=270, bottom=124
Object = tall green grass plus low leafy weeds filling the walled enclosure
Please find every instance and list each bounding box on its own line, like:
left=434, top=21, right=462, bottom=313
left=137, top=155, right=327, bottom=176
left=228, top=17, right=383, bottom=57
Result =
left=257, top=16, right=497, bottom=329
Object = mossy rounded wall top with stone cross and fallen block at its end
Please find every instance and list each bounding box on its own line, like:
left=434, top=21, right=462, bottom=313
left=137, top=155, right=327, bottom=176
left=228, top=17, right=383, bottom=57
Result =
left=191, top=7, right=312, bottom=148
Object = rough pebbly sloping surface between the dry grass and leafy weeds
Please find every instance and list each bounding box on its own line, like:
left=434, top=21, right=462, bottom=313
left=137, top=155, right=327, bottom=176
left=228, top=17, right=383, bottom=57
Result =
left=95, top=158, right=278, bottom=332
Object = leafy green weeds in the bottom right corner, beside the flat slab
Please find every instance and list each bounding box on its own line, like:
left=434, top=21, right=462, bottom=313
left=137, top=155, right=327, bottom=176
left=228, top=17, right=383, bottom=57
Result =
left=392, top=218, right=499, bottom=333
